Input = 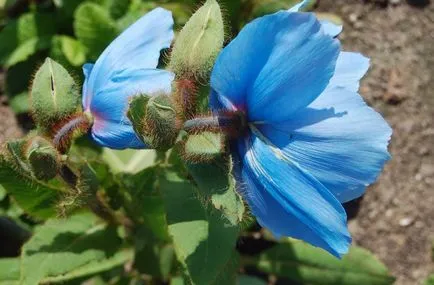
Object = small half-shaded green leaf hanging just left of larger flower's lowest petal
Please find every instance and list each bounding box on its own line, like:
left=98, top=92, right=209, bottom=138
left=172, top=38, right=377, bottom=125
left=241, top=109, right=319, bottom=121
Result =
left=188, top=159, right=245, bottom=225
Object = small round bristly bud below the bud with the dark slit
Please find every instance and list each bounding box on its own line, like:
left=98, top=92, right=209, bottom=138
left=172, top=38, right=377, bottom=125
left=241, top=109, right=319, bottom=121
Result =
left=25, top=137, right=60, bottom=181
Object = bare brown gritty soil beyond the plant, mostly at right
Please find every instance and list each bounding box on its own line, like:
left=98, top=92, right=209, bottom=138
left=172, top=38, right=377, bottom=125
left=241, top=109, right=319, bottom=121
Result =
left=0, top=0, right=434, bottom=285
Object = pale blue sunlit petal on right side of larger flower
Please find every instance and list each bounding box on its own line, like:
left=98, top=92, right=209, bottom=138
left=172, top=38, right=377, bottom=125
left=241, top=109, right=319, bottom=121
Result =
left=259, top=53, right=392, bottom=203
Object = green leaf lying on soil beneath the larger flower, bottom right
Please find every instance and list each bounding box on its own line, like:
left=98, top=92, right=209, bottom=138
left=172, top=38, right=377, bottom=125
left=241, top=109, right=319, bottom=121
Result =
left=247, top=240, right=395, bottom=285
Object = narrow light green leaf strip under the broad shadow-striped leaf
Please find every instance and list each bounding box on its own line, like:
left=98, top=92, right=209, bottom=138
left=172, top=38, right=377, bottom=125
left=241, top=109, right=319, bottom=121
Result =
left=42, top=250, right=134, bottom=284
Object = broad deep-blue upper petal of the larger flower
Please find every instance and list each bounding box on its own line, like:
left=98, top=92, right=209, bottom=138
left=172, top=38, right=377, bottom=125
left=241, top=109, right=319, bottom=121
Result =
left=211, top=12, right=339, bottom=122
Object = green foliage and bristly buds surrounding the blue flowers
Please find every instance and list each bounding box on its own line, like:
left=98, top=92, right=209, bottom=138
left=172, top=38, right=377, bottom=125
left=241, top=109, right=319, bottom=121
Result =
left=0, top=0, right=396, bottom=285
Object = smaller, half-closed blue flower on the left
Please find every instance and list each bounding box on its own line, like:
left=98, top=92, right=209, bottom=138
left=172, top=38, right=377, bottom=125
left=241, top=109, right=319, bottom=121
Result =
left=83, top=8, right=174, bottom=149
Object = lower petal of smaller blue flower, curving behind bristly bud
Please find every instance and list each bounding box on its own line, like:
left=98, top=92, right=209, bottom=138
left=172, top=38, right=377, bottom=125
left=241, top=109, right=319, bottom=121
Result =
left=90, top=69, right=174, bottom=149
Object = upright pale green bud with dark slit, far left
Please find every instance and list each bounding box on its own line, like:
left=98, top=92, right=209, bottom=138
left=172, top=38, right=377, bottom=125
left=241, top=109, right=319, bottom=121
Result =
left=31, top=58, right=81, bottom=130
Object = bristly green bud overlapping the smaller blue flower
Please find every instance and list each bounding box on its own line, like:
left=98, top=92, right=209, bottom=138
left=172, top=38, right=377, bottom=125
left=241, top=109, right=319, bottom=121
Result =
left=128, top=94, right=178, bottom=150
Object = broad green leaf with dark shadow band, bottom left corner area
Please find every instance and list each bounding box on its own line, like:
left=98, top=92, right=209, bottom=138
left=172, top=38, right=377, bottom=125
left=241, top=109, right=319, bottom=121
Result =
left=20, top=213, right=121, bottom=285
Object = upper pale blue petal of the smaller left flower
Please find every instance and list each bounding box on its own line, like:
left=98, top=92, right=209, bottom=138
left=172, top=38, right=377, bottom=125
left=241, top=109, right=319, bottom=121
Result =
left=83, top=8, right=173, bottom=108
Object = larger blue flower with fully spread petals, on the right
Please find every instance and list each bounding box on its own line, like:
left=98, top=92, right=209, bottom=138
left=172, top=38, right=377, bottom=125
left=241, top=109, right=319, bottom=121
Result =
left=210, top=1, right=391, bottom=257
